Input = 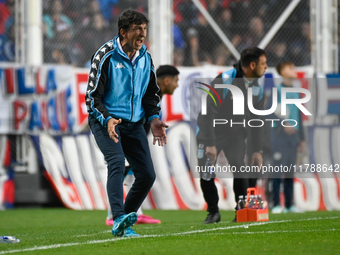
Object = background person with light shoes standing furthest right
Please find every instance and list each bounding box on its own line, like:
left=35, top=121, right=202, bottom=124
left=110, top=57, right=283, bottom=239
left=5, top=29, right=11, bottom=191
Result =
left=271, top=62, right=305, bottom=213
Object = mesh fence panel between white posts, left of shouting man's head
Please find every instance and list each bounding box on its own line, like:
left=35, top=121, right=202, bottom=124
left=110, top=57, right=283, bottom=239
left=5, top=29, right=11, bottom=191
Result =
left=43, top=0, right=148, bottom=67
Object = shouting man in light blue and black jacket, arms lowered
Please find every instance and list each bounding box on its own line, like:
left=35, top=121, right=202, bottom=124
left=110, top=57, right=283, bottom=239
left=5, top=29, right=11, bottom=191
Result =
left=85, top=10, right=167, bottom=236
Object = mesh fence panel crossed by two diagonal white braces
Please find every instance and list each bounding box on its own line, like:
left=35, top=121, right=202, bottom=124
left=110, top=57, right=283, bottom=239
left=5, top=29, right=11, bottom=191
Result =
left=174, top=0, right=311, bottom=66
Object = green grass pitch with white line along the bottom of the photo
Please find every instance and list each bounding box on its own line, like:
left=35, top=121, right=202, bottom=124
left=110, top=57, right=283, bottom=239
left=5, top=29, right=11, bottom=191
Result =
left=0, top=208, right=340, bottom=255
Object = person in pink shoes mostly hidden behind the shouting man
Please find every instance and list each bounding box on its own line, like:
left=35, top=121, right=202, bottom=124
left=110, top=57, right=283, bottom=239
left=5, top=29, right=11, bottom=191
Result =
left=105, top=65, right=179, bottom=226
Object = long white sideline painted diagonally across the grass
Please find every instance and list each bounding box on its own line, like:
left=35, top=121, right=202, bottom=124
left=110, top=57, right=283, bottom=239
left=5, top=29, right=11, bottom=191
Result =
left=0, top=217, right=340, bottom=254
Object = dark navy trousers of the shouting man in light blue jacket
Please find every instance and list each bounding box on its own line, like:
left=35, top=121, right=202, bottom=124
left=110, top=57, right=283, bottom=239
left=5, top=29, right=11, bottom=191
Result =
left=89, top=115, right=156, bottom=219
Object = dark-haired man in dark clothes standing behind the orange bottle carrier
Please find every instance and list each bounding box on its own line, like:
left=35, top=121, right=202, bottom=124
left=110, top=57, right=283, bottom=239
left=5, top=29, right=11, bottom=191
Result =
left=197, top=47, right=268, bottom=223
